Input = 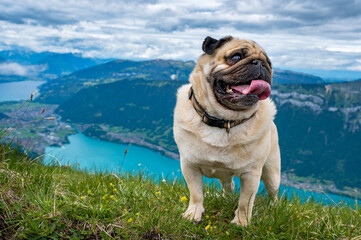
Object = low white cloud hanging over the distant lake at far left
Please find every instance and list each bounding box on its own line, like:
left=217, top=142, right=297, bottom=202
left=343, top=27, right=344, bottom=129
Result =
left=0, top=62, right=47, bottom=77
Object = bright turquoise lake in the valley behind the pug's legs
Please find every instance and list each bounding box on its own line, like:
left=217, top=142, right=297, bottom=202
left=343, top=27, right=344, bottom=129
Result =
left=44, top=133, right=355, bottom=204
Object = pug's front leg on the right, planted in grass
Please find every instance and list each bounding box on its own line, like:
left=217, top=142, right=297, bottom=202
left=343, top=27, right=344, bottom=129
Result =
left=231, top=173, right=261, bottom=227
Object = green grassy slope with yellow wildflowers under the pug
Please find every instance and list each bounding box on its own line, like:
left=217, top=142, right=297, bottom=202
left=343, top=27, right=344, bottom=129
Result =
left=0, top=140, right=361, bottom=240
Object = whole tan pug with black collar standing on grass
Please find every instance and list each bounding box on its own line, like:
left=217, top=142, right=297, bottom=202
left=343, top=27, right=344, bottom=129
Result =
left=173, top=36, right=281, bottom=226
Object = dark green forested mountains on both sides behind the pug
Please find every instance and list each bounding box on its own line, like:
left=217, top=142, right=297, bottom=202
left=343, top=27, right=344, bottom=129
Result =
left=38, top=60, right=361, bottom=193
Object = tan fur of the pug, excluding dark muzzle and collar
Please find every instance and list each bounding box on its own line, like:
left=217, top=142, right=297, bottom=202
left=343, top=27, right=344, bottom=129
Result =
left=174, top=36, right=280, bottom=226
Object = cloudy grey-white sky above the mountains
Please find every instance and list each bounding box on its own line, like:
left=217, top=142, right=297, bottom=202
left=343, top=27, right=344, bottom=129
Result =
left=0, top=0, right=361, bottom=71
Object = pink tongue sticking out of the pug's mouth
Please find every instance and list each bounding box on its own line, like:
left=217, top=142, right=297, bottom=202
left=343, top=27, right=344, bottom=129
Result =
left=231, top=80, right=271, bottom=100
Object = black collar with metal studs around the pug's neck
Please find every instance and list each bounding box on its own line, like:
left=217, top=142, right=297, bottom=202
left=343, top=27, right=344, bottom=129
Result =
left=188, top=87, right=256, bottom=133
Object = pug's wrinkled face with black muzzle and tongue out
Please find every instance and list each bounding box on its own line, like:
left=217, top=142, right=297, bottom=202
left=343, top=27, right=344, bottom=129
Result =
left=202, top=37, right=272, bottom=111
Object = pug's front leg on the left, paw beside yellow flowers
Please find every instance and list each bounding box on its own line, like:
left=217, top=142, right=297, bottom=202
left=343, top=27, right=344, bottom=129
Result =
left=181, top=161, right=204, bottom=223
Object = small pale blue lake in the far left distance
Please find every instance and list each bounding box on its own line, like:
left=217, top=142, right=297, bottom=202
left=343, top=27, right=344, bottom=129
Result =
left=0, top=80, right=45, bottom=102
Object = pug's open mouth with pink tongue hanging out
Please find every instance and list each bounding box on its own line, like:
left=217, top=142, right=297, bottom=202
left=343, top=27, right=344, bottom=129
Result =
left=222, top=79, right=271, bottom=100
